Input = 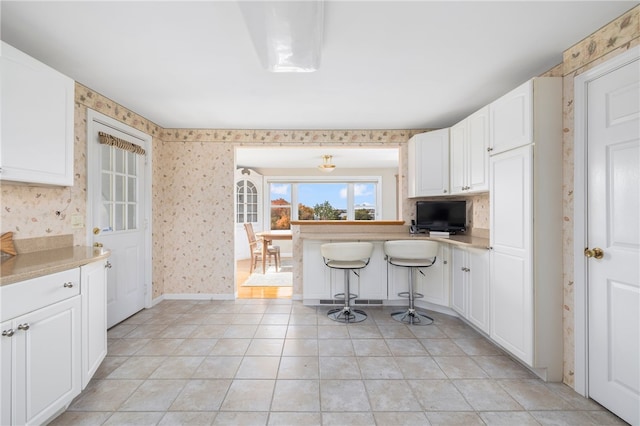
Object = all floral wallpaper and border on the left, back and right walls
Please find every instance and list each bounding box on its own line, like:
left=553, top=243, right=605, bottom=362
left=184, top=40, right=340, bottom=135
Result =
left=0, top=6, right=640, bottom=385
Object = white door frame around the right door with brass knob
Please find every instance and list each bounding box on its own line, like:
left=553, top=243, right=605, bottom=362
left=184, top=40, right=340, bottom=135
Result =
left=573, top=46, right=640, bottom=397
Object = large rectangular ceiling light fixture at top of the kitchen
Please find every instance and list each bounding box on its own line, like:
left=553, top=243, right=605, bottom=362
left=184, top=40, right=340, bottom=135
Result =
left=238, top=0, right=324, bottom=72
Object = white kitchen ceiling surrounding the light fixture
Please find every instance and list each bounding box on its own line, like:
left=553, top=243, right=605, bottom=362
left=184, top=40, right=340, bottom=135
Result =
left=0, top=0, right=637, bottom=132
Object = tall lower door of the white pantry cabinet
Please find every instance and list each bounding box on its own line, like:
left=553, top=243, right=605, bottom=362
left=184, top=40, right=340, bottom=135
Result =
left=489, top=146, right=533, bottom=365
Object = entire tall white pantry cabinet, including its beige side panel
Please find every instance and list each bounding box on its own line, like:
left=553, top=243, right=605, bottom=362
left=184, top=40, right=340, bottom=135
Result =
left=489, top=77, right=563, bottom=381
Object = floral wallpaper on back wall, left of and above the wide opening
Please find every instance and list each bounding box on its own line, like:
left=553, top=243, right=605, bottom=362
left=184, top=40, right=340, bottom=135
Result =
left=154, top=129, right=420, bottom=298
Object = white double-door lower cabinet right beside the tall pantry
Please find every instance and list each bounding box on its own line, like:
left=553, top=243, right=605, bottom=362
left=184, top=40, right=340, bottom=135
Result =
left=451, top=247, right=489, bottom=333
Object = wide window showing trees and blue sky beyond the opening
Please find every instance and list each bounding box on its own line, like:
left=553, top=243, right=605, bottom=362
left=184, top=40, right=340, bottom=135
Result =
left=268, top=178, right=380, bottom=230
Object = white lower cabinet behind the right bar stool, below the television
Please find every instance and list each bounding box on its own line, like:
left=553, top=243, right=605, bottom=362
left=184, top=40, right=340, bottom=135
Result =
left=388, top=244, right=449, bottom=306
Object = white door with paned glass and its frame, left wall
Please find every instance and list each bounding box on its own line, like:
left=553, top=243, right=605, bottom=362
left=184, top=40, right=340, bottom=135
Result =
left=87, top=111, right=151, bottom=327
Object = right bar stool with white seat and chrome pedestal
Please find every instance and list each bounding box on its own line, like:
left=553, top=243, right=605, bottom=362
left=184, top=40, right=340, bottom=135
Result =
left=384, top=240, right=438, bottom=325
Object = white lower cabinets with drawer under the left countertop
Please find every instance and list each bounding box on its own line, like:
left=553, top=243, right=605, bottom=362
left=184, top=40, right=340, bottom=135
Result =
left=0, top=261, right=107, bottom=425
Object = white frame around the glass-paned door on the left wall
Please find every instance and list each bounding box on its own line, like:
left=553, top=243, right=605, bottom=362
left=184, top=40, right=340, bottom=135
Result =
left=85, top=108, right=153, bottom=308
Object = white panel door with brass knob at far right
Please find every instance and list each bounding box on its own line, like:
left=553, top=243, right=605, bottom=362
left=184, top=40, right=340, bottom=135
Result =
left=587, top=50, right=640, bottom=425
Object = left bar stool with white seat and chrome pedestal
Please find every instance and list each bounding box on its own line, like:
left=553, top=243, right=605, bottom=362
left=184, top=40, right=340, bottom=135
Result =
left=320, top=242, right=373, bottom=323
